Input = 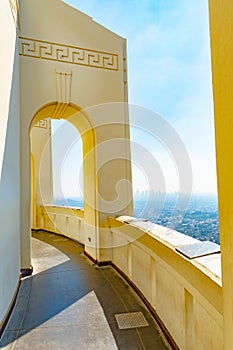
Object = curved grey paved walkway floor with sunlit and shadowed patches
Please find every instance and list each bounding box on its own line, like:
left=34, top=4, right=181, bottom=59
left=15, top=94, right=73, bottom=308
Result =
left=0, top=232, right=168, bottom=350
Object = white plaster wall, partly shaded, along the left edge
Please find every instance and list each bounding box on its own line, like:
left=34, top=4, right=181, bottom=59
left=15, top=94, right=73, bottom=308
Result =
left=0, top=0, right=20, bottom=326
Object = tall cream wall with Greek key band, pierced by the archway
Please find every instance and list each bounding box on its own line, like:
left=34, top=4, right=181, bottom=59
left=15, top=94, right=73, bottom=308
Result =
left=19, top=0, right=133, bottom=266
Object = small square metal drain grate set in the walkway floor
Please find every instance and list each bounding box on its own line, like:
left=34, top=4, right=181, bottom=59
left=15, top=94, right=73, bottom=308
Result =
left=115, top=312, right=149, bottom=329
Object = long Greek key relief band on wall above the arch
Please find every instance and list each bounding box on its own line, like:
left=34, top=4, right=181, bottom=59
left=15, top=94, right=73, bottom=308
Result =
left=19, top=37, right=118, bottom=71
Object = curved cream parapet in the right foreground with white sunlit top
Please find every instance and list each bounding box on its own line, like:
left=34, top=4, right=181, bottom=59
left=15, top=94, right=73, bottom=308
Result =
left=109, top=217, right=223, bottom=350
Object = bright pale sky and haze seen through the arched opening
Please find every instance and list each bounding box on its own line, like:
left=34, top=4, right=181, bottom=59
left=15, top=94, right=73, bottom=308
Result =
left=51, top=119, right=84, bottom=209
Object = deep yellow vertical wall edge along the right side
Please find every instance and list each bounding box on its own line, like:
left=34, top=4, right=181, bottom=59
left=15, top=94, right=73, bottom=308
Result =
left=209, top=0, right=233, bottom=350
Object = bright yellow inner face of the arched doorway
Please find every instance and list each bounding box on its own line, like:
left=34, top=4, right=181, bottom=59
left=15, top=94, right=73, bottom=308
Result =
left=29, top=102, right=98, bottom=264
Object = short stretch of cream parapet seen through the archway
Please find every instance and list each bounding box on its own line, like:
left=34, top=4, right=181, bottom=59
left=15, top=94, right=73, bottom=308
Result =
left=37, top=205, right=85, bottom=244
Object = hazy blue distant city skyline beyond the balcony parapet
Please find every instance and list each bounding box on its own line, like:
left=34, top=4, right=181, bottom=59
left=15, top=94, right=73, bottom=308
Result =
left=54, top=192, right=220, bottom=244
